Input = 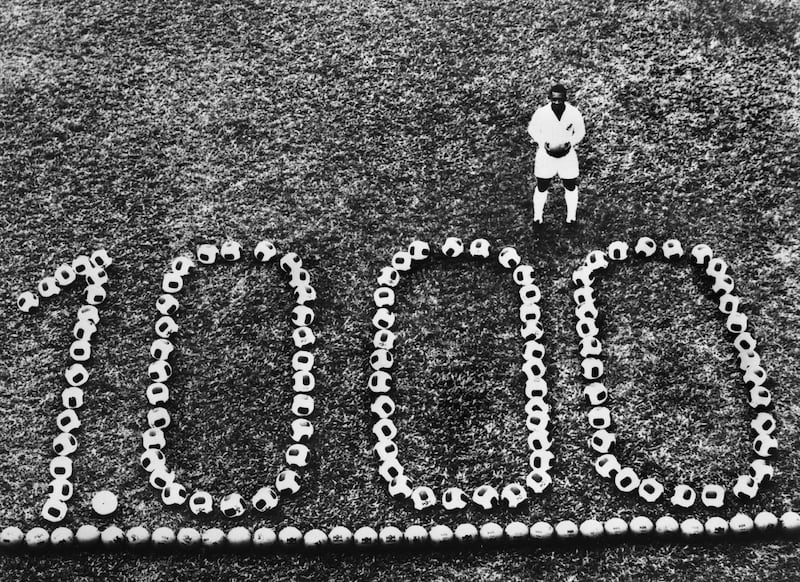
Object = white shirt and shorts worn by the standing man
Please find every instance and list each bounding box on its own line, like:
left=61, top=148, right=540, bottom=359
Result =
left=528, top=103, right=586, bottom=180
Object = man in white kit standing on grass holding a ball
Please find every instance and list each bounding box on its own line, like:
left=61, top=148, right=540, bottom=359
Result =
left=528, top=85, right=586, bottom=224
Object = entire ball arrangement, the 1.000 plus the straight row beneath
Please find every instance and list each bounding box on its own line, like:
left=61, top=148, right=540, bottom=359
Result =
left=7, top=237, right=800, bottom=549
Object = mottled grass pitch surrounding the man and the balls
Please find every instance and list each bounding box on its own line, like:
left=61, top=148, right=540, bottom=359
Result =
left=0, top=1, right=800, bottom=580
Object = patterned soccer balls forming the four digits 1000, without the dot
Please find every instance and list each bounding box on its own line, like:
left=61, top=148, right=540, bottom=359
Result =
left=18, top=237, right=777, bottom=522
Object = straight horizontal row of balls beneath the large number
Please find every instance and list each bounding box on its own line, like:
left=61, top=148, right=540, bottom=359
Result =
left=0, top=511, right=800, bottom=551
